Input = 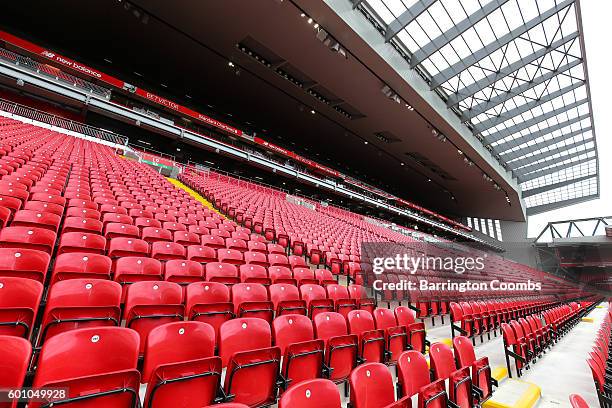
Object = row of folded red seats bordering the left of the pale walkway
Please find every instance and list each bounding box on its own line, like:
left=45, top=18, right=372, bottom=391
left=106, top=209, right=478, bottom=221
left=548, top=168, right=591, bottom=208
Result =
left=501, top=302, right=586, bottom=377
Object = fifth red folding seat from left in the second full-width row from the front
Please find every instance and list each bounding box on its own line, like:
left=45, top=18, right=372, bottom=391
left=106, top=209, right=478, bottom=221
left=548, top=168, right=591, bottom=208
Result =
left=232, top=283, right=274, bottom=324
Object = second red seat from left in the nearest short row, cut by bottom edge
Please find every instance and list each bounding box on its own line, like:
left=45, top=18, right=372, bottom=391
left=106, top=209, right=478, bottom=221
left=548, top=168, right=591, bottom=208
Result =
left=349, top=363, right=395, bottom=408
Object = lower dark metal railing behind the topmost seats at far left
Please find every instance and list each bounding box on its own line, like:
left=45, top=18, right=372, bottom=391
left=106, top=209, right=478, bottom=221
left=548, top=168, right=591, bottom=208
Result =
left=0, top=98, right=129, bottom=146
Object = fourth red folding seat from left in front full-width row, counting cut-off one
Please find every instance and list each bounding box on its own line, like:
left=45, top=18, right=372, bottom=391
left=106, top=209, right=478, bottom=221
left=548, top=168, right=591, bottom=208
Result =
left=219, top=318, right=281, bottom=406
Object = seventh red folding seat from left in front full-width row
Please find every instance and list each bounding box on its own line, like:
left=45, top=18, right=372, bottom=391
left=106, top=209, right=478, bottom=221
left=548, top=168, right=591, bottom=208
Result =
left=347, top=310, right=385, bottom=363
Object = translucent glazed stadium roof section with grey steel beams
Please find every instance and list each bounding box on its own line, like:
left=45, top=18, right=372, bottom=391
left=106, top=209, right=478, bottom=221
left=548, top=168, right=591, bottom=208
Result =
left=354, top=0, right=599, bottom=214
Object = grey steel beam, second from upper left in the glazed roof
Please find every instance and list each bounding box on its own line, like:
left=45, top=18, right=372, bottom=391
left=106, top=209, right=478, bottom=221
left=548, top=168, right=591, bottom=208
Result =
left=410, top=0, right=509, bottom=68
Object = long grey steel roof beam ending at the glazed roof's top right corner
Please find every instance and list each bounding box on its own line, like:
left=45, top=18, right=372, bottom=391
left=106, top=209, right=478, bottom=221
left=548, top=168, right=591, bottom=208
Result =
left=430, top=0, right=575, bottom=90
